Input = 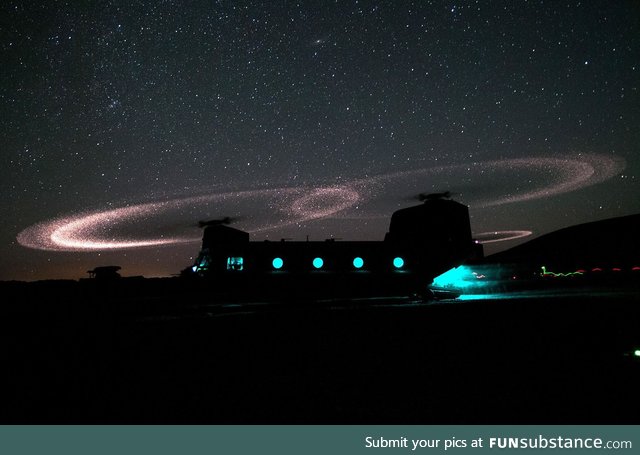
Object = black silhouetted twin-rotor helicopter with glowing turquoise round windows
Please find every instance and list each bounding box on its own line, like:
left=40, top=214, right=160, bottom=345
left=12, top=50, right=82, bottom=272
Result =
left=183, top=192, right=482, bottom=299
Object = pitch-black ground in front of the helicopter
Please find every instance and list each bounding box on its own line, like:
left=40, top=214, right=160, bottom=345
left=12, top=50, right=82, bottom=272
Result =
left=0, top=280, right=640, bottom=424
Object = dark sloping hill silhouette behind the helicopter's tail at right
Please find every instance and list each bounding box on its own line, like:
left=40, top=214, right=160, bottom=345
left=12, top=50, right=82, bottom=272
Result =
left=485, top=214, right=640, bottom=267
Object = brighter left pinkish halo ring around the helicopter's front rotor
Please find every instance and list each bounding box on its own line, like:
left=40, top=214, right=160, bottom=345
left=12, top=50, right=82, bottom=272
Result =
left=17, top=185, right=360, bottom=255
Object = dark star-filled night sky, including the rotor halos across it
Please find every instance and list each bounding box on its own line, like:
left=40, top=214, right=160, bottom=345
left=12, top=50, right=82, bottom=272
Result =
left=0, top=0, right=640, bottom=280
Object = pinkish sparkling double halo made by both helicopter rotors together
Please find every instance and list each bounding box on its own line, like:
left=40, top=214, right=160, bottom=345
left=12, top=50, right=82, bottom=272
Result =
left=17, top=155, right=625, bottom=251
